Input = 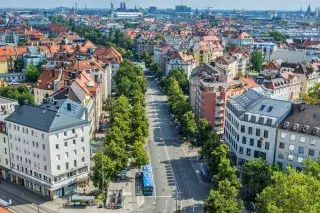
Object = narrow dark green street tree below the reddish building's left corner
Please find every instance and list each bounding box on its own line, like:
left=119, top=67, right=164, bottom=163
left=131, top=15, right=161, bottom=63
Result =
left=192, top=118, right=213, bottom=147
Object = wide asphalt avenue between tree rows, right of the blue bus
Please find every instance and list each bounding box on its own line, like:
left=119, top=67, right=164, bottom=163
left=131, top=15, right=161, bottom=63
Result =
left=135, top=73, right=210, bottom=213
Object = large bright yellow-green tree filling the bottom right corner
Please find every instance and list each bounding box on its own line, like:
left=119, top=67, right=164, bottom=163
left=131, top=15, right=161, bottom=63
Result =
left=256, top=167, right=320, bottom=213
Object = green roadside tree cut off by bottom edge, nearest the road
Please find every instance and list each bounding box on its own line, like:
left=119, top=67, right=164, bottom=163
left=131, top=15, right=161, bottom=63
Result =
left=204, top=180, right=243, bottom=213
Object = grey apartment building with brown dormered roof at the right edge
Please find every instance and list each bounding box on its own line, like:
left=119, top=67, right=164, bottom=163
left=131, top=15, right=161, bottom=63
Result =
left=275, top=104, right=320, bottom=170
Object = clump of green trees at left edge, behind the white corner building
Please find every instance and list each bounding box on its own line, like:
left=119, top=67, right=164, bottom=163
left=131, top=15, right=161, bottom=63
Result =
left=0, top=86, right=34, bottom=105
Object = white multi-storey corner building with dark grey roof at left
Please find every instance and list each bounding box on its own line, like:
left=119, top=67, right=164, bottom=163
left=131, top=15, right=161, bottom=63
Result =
left=5, top=103, right=90, bottom=199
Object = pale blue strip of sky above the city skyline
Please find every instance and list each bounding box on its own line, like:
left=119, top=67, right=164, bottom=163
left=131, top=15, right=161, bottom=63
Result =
left=0, top=0, right=320, bottom=10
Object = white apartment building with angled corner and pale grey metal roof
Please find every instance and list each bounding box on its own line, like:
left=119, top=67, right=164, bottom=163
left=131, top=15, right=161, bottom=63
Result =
left=224, top=88, right=291, bottom=169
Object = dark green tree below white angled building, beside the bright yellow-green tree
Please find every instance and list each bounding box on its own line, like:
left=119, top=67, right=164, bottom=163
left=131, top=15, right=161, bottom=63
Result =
left=242, top=158, right=280, bottom=196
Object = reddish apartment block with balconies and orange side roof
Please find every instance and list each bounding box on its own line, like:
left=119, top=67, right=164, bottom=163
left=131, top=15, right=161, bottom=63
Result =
left=190, top=64, right=258, bottom=134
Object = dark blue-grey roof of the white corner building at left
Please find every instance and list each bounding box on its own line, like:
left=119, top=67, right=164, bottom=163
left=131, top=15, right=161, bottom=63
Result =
left=5, top=105, right=89, bottom=132
